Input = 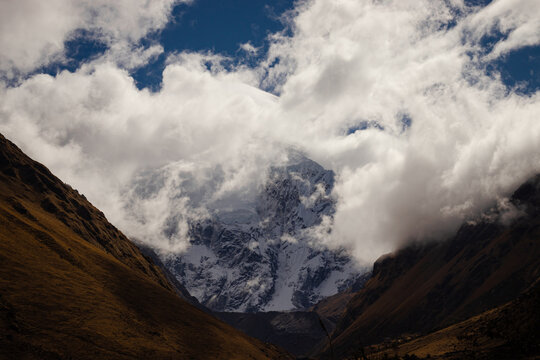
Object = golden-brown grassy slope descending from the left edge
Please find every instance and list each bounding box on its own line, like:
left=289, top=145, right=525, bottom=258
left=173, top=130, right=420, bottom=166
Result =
left=0, top=135, right=292, bottom=359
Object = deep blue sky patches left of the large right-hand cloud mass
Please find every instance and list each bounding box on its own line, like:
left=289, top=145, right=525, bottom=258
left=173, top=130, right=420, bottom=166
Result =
left=41, top=0, right=294, bottom=91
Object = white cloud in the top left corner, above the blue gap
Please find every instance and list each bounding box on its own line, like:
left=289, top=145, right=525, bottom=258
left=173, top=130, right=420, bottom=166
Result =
left=0, top=0, right=179, bottom=79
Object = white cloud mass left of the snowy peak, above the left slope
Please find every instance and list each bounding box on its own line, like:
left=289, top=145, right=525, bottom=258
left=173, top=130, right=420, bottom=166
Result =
left=0, top=58, right=280, bottom=249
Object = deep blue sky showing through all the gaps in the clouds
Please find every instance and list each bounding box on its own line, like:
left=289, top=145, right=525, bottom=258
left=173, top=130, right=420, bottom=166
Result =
left=36, top=0, right=540, bottom=94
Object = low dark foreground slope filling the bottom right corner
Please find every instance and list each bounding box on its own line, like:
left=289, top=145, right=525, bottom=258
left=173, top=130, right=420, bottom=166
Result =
left=365, top=279, right=540, bottom=360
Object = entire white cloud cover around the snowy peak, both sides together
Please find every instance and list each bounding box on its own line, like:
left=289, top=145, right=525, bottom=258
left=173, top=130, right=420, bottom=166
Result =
left=0, top=0, right=540, bottom=262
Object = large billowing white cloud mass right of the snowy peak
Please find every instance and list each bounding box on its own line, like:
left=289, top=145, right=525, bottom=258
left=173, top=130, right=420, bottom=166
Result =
left=255, top=1, right=540, bottom=259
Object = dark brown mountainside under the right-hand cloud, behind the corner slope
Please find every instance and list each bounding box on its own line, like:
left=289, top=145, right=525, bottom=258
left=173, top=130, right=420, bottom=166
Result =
left=320, top=179, right=540, bottom=356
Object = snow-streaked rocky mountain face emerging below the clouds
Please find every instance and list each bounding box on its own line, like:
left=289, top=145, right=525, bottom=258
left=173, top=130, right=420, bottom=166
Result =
left=164, top=154, right=365, bottom=312
